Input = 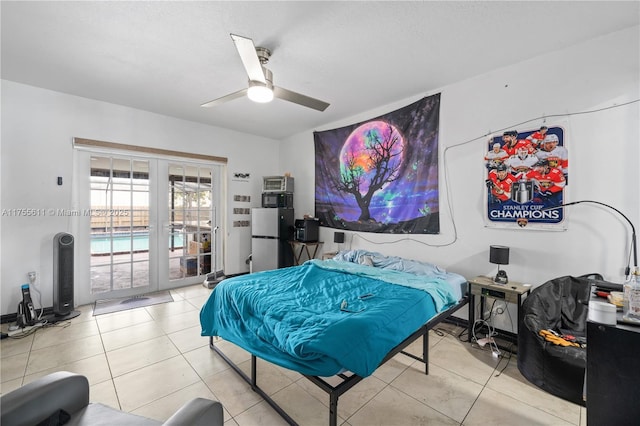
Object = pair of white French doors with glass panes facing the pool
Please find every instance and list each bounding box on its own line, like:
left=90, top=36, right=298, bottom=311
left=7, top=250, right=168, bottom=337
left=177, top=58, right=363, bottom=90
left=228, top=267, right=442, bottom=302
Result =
left=77, top=151, right=222, bottom=301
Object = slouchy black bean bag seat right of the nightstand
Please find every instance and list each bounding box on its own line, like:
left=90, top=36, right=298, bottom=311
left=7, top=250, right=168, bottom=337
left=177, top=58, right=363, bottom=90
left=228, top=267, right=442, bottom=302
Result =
left=518, top=276, right=591, bottom=405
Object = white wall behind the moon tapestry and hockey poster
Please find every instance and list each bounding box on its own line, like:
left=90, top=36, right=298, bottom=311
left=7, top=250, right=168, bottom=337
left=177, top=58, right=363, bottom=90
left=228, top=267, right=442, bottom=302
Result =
left=280, top=27, right=640, bottom=329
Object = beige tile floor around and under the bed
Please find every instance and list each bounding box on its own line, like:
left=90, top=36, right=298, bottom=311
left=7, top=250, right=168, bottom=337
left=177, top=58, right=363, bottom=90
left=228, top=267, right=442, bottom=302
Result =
left=0, top=285, right=586, bottom=426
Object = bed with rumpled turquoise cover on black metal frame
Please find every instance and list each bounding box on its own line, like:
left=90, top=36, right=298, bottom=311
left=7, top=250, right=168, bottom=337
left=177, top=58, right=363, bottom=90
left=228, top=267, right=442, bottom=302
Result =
left=200, top=250, right=468, bottom=426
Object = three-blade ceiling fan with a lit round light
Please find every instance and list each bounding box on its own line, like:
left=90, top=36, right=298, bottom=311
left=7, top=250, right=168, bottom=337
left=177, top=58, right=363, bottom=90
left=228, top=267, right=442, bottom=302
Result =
left=201, top=34, right=329, bottom=111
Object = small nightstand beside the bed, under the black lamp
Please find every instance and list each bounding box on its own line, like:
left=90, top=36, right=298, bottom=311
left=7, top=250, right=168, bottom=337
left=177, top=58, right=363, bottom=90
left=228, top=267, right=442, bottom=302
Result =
left=468, top=276, right=531, bottom=342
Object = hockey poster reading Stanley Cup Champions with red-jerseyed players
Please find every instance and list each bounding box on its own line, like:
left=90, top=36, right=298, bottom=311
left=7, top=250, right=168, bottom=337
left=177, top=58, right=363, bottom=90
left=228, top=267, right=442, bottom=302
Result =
left=484, top=126, right=569, bottom=228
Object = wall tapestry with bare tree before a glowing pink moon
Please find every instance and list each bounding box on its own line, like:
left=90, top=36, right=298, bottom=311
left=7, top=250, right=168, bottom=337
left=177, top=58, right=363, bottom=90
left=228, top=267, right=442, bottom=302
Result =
left=314, top=94, right=440, bottom=234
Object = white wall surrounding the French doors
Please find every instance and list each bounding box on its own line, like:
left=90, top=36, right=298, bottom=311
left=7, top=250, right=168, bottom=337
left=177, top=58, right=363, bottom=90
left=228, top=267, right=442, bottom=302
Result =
left=0, top=80, right=282, bottom=315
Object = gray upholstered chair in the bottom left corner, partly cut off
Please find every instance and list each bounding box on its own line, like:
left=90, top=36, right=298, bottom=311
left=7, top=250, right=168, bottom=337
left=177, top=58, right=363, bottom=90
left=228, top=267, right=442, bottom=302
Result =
left=0, top=371, right=224, bottom=426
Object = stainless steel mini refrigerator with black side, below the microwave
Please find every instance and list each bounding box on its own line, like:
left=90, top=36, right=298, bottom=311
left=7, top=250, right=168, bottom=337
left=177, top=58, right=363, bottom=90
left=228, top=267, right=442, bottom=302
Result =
left=251, top=208, right=294, bottom=272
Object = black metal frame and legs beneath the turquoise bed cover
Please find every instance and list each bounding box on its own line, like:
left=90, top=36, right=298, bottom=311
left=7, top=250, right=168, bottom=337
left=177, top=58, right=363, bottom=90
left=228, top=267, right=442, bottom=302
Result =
left=209, top=296, right=469, bottom=426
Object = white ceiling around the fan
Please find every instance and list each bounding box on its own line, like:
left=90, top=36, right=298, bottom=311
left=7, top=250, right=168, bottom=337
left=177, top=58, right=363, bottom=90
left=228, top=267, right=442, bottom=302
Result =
left=1, top=1, right=640, bottom=139
